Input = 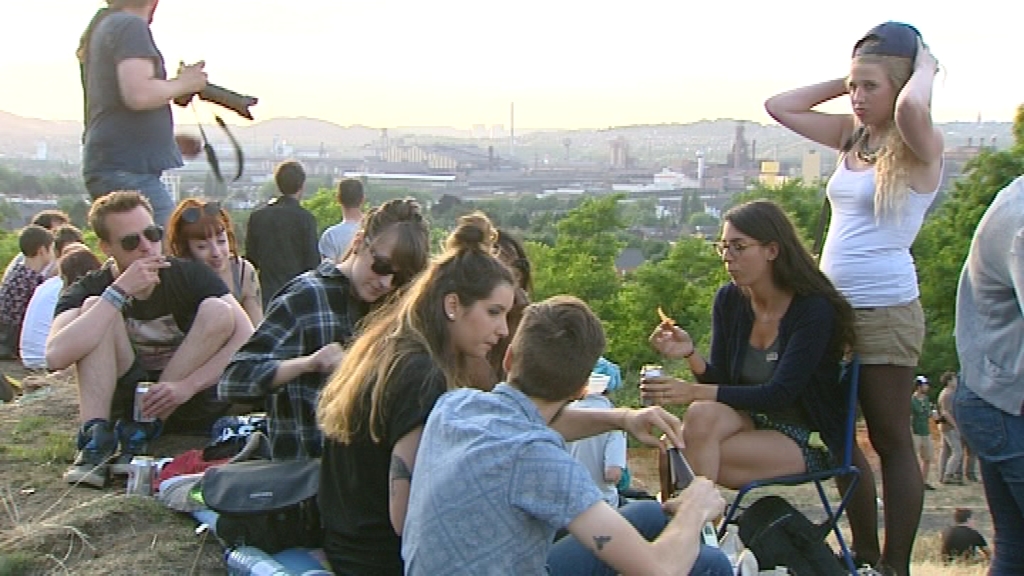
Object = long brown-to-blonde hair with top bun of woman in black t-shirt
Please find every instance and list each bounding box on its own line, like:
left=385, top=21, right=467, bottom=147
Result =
left=316, top=212, right=513, bottom=444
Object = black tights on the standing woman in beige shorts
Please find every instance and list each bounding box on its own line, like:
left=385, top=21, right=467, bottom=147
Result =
left=847, top=365, right=925, bottom=576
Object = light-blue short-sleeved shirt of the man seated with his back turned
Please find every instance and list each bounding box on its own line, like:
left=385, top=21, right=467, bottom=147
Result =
left=401, top=383, right=601, bottom=576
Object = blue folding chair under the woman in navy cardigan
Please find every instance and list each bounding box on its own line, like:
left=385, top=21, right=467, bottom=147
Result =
left=718, top=356, right=860, bottom=575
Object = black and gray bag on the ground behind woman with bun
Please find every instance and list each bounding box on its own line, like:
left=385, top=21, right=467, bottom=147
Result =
left=203, top=459, right=324, bottom=554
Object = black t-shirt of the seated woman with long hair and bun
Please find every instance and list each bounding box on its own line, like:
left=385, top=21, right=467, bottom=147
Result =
left=318, top=354, right=446, bottom=576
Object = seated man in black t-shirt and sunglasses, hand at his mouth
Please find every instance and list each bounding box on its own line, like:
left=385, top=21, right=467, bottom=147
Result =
left=46, top=192, right=253, bottom=487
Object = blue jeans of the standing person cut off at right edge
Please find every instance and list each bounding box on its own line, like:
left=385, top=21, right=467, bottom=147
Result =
left=953, top=380, right=1024, bottom=576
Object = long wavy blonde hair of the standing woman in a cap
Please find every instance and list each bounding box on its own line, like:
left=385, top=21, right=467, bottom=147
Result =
left=844, top=54, right=921, bottom=220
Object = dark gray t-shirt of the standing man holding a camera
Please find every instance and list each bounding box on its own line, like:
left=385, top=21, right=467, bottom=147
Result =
left=82, top=11, right=182, bottom=176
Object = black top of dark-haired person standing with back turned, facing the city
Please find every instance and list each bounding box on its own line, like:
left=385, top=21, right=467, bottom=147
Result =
left=246, top=196, right=321, bottom=308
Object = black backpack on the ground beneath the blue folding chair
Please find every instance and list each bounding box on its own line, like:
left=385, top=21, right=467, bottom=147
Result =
left=737, top=496, right=847, bottom=576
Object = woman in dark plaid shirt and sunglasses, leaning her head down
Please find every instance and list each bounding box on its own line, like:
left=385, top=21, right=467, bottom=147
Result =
left=217, top=199, right=430, bottom=459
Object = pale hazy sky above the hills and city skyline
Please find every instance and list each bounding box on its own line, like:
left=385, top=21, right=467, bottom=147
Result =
left=0, top=0, right=1024, bottom=128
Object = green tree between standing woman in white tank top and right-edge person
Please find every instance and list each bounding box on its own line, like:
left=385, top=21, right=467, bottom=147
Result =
left=913, top=106, right=1024, bottom=380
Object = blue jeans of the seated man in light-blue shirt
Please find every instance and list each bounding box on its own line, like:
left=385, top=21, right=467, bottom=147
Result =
left=548, top=500, right=732, bottom=576
